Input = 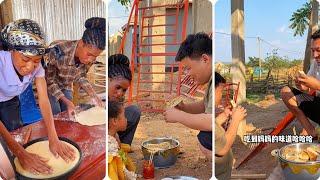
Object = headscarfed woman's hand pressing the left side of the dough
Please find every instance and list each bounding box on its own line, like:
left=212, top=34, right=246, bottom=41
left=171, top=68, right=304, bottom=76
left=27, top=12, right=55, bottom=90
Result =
left=17, top=150, right=52, bottom=174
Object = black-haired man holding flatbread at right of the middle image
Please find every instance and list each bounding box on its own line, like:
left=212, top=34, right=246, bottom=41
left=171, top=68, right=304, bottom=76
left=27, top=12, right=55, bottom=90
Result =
left=164, top=33, right=212, bottom=160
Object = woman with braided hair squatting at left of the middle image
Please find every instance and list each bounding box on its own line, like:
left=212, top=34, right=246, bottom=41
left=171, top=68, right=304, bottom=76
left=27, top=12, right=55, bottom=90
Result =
left=108, top=54, right=141, bottom=151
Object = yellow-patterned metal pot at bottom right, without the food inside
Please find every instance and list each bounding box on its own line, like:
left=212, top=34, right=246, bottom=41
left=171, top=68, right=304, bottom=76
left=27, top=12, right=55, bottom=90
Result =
left=274, top=143, right=320, bottom=180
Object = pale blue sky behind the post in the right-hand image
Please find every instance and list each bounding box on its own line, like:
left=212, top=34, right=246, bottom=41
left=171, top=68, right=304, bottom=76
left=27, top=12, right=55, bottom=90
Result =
left=215, top=0, right=307, bottom=62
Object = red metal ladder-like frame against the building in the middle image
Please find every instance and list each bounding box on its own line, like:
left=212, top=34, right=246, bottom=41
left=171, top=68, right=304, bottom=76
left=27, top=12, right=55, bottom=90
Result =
left=119, top=0, right=204, bottom=112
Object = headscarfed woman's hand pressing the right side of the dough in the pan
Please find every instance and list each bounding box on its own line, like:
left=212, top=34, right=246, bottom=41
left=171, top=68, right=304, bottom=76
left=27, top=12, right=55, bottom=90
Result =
left=49, top=140, right=75, bottom=162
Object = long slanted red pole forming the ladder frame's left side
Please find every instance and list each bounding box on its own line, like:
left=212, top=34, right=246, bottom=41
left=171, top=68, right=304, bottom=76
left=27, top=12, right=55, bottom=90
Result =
left=128, top=0, right=139, bottom=104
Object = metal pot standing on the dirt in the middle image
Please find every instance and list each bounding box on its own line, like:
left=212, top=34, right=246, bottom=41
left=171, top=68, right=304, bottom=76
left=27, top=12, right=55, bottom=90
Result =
left=141, top=137, right=180, bottom=168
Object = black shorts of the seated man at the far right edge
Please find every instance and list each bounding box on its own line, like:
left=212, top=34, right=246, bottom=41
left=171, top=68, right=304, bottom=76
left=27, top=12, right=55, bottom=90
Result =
left=290, top=87, right=320, bottom=124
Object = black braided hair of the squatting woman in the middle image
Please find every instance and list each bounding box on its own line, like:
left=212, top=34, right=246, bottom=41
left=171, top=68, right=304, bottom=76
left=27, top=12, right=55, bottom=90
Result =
left=108, top=54, right=132, bottom=81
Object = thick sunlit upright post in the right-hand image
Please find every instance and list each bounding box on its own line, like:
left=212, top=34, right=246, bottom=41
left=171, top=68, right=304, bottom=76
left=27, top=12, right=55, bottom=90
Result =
left=231, top=0, right=246, bottom=140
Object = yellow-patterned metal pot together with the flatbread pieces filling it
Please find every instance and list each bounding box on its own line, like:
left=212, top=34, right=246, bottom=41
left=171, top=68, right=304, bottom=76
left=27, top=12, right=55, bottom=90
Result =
left=272, top=143, right=320, bottom=180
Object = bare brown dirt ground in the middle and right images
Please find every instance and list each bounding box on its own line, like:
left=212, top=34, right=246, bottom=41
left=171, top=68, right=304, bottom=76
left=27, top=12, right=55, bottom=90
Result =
left=130, top=95, right=312, bottom=180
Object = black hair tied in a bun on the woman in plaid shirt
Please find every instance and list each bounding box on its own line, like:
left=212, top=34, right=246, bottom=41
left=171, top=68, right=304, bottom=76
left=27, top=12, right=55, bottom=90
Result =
left=82, top=17, right=106, bottom=50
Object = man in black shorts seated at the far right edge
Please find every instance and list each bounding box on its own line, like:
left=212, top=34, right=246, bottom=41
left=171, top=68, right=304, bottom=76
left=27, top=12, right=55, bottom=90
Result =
left=281, top=30, right=320, bottom=137
